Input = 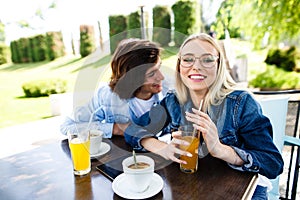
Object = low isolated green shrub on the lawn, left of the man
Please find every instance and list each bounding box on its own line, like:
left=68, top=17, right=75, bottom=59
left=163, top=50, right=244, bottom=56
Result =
left=22, top=79, right=67, bottom=97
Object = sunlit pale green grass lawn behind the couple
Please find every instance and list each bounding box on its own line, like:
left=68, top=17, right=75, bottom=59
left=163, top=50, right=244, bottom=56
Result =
left=0, top=40, right=265, bottom=128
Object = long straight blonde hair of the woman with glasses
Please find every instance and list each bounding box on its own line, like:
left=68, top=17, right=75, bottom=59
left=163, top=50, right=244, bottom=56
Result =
left=176, top=33, right=236, bottom=111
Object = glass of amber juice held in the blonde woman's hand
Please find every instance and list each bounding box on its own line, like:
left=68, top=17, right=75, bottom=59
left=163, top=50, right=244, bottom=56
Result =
left=179, top=125, right=200, bottom=173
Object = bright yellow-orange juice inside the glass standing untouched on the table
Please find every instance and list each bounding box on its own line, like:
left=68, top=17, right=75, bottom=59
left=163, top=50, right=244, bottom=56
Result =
left=69, top=138, right=91, bottom=173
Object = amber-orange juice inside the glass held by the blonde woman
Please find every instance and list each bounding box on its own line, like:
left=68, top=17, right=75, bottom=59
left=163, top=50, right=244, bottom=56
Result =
left=180, top=136, right=200, bottom=173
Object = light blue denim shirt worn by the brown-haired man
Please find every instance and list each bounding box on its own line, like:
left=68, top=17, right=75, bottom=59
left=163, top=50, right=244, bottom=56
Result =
left=60, top=83, right=168, bottom=138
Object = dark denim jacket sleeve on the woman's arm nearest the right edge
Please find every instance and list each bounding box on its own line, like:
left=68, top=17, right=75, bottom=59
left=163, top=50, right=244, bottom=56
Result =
left=230, top=95, right=283, bottom=179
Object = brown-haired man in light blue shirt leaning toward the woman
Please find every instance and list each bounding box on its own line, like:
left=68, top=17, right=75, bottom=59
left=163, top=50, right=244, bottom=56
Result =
left=61, top=38, right=168, bottom=138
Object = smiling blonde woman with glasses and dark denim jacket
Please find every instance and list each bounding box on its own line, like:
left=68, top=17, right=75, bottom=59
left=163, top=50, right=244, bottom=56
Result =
left=124, top=34, right=283, bottom=199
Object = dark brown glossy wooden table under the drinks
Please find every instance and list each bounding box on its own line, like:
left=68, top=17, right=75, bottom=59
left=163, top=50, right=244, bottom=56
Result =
left=0, top=137, right=257, bottom=200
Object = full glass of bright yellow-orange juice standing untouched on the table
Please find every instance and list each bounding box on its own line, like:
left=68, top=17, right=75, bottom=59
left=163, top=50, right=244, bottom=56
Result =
left=68, top=127, right=91, bottom=175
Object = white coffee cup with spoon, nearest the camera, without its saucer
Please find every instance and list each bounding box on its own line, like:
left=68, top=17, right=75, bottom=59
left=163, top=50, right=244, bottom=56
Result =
left=122, top=155, right=154, bottom=192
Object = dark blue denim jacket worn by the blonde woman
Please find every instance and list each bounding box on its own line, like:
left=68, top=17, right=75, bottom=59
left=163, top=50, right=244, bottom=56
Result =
left=125, top=91, right=283, bottom=179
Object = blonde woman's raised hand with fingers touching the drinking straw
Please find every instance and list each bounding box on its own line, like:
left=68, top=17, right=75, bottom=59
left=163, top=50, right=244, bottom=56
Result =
left=186, top=108, right=222, bottom=157
